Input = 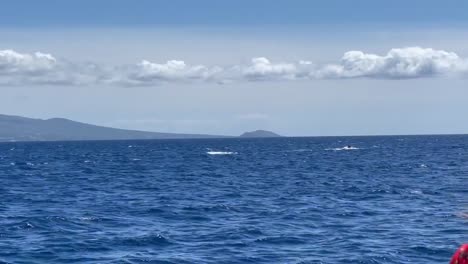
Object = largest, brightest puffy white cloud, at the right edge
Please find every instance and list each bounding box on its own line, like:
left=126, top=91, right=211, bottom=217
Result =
left=315, top=47, right=468, bottom=79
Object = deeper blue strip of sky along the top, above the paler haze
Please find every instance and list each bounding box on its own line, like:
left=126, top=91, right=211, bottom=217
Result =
left=0, top=0, right=468, bottom=27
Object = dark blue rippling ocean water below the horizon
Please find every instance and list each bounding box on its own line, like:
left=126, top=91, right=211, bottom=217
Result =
left=0, top=136, right=468, bottom=264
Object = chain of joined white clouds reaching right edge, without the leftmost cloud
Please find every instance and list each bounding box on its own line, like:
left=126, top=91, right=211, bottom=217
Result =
left=106, top=47, right=468, bottom=85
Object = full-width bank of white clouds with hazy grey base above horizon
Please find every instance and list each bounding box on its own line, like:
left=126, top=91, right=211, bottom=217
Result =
left=0, top=47, right=468, bottom=86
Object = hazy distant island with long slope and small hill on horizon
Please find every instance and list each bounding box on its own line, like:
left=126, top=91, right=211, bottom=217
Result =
left=0, top=115, right=279, bottom=142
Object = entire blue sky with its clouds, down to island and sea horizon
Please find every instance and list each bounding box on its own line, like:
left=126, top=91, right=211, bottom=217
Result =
left=0, top=0, right=468, bottom=136
